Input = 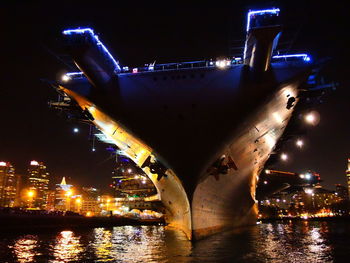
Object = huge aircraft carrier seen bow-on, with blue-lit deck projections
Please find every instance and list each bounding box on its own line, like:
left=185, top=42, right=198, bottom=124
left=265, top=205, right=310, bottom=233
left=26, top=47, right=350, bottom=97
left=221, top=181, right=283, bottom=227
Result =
left=49, top=8, right=313, bottom=239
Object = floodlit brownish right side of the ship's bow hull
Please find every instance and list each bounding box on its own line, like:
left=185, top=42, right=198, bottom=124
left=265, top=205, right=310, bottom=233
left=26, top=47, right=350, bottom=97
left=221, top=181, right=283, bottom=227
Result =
left=191, top=79, right=298, bottom=239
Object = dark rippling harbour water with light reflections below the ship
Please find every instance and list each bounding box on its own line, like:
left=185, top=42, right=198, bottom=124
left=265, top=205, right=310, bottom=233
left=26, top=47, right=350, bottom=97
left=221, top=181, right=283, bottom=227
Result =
left=0, top=221, right=350, bottom=263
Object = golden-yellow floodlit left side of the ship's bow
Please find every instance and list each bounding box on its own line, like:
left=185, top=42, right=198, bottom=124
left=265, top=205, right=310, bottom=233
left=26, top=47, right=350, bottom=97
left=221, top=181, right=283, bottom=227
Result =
left=61, top=87, right=192, bottom=239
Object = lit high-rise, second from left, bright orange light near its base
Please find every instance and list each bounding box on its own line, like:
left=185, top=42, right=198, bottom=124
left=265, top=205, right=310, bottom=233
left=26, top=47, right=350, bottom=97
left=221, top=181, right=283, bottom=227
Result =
left=28, top=161, right=49, bottom=209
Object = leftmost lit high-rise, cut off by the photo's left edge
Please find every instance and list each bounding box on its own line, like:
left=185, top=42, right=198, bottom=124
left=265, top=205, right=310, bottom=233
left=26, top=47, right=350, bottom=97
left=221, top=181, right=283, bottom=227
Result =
left=0, top=162, right=19, bottom=207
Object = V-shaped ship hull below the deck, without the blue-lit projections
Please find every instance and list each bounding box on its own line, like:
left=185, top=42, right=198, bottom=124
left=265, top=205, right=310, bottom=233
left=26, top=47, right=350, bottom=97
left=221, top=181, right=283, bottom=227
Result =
left=61, top=65, right=308, bottom=239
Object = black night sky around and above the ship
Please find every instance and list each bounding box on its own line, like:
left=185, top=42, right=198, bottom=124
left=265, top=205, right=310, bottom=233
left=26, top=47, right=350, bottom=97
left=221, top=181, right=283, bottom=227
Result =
left=0, top=0, right=350, bottom=188
